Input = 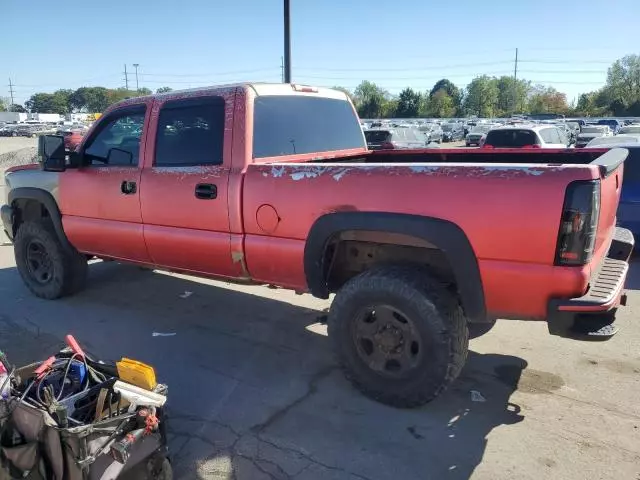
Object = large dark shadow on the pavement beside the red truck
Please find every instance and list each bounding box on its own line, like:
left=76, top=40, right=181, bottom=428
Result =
left=0, top=263, right=527, bottom=480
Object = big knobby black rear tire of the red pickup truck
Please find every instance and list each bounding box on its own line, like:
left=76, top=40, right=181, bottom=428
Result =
left=328, top=266, right=469, bottom=408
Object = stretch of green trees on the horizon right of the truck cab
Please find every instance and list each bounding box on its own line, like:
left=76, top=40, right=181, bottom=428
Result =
left=342, top=55, right=640, bottom=118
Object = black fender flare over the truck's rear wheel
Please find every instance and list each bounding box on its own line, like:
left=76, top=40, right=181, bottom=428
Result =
left=304, top=212, right=489, bottom=323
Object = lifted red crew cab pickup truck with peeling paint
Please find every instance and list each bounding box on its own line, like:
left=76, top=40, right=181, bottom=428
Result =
left=1, top=84, right=633, bottom=407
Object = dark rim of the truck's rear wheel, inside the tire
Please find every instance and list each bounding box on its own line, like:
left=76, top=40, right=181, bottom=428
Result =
left=352, top=305, right=423, bottom=377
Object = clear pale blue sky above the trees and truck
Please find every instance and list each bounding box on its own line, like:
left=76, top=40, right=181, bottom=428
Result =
left=0, top=0, right=640, bottom=104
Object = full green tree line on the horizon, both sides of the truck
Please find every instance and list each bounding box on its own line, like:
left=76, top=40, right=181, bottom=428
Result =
left=0, top=55, right=640, bottom=118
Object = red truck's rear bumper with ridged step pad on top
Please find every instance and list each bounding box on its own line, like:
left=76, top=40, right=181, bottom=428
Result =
left=547, top=228, right=634, bottom=336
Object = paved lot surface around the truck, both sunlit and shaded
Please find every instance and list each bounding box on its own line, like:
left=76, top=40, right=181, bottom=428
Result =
left=0, top=137, right=640, bottom=480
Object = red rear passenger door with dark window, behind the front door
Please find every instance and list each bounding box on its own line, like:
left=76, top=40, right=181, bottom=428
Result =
left=140, top=92, right=242, bottom=277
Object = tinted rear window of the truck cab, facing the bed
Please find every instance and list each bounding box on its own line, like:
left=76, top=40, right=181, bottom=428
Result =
left=253, top=95, right=365, bottom=158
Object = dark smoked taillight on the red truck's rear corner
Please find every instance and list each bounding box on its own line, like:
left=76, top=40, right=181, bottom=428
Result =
left=555, top=180, right=600, bottom=265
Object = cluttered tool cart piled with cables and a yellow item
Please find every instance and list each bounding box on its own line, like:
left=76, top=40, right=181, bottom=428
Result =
left=0, top=335, right=172, bottom=480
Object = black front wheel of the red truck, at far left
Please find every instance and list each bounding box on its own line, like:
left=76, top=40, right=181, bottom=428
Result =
left=14, top=221, right=87, bottom=300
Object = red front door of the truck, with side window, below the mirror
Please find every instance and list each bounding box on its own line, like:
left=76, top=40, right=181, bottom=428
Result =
left=59, top=104, right=150, bottom=263
